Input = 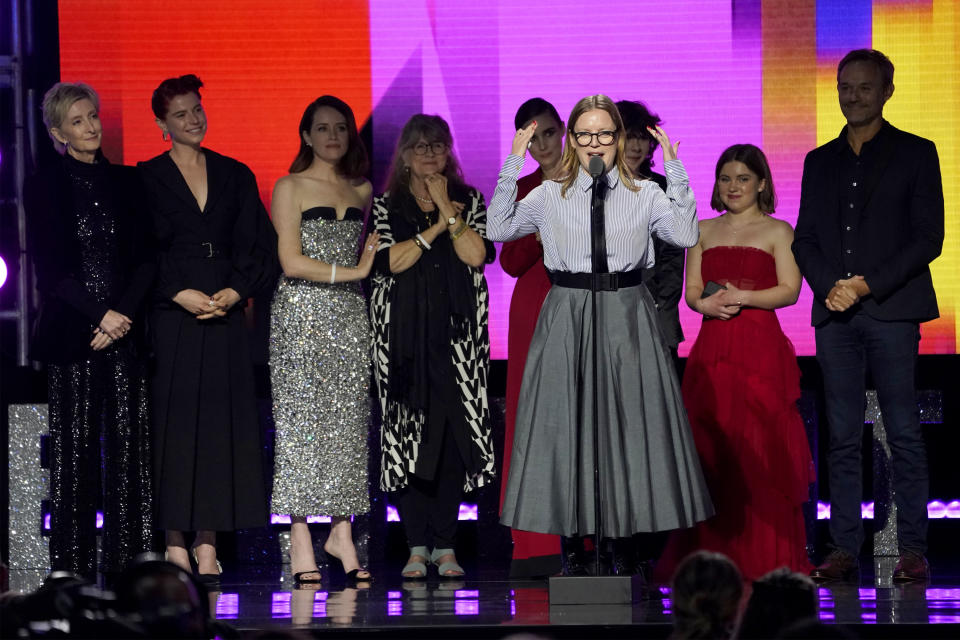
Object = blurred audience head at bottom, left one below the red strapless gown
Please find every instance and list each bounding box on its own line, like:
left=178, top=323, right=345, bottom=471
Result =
left=671, top=551, right=743, bottom=639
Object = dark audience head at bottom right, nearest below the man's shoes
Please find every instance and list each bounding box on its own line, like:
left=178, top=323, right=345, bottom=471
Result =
left=737, top=567, right=817, bottom=640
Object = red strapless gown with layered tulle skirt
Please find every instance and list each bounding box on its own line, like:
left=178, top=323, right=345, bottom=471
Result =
left=656, top=247, right=815, bottom=581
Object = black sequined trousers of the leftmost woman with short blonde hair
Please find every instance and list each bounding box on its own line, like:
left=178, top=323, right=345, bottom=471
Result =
left=48, top=343, right=153, bottom=580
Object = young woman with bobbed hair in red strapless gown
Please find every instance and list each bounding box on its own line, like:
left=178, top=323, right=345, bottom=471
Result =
left=656, top=145, right=815, bottom=580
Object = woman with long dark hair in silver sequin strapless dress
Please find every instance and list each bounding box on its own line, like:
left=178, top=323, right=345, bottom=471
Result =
left=270, top=96, right=378, bottom=584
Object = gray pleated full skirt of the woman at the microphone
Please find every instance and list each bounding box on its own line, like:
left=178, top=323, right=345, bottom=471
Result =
left=500, top=286, right=713, bottom=537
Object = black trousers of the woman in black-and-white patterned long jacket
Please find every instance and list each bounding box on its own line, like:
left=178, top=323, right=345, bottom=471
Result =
left=397, top=423, right=465, bottom=549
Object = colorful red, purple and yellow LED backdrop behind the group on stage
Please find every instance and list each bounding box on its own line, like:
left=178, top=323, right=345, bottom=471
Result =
left=60, top=0, right=960, bottom=358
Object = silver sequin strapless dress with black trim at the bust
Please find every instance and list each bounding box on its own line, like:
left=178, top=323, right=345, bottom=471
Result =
left=270, top=207, right=370, bottom=516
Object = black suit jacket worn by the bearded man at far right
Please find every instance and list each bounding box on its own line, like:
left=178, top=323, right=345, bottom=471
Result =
left=793, top=122, right=944, bottom=326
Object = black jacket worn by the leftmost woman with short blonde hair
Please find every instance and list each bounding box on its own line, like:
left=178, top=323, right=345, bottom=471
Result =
left=24, top=158, right=156, bottom=363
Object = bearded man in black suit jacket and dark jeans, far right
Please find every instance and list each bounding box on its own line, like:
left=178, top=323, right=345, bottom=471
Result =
left=793, top=49, right=944, bottom=581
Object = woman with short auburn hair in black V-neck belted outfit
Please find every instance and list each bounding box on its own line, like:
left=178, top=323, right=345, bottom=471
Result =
left=140, top=75, right=278, bottom=582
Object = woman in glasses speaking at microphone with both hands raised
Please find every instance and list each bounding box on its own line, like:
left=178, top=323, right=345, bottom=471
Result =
left=487, top=95, right=713, bottom=564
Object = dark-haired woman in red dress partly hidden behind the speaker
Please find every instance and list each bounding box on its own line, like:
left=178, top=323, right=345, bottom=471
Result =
left=500, top=98, right=564, bottom=578
